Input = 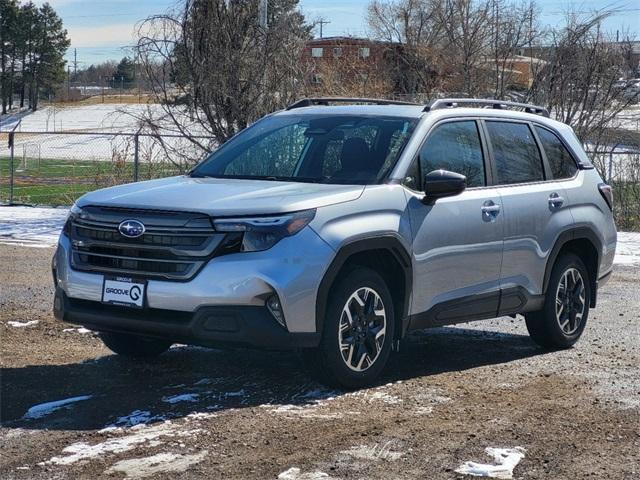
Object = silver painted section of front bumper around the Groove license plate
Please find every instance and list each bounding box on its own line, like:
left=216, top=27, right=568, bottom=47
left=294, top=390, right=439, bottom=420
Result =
left=54, top=227, right=335, bottom=333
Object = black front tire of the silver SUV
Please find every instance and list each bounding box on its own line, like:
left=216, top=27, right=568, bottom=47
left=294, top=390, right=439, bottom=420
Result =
left=303, top=267, right=395, bottom=389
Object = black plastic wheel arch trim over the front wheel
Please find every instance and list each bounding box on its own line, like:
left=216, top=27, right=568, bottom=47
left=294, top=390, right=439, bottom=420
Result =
left=316, top=232, right=413, bottom=338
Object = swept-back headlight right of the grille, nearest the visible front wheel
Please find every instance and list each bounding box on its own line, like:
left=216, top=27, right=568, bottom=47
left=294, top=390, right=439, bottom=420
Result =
left=213, top=210, right=316, bottom=252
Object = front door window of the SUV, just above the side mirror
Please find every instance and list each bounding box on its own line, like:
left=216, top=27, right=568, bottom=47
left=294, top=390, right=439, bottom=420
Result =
left=420, top=120, right=485, bottom=187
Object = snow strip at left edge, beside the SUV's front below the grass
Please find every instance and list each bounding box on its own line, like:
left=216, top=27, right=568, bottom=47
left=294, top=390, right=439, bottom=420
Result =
left=0, top=207, right=69, bottom=247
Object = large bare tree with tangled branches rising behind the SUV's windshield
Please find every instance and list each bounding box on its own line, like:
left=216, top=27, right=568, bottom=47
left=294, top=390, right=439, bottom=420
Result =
left=137, top=0, right=310, bottom=159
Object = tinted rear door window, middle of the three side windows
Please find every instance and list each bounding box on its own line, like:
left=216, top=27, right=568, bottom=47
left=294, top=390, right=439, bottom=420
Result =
left=486, top=121, right=544, bottom=185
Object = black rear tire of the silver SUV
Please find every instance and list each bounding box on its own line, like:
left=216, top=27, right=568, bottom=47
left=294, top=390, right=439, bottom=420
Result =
left=525, top=253, right=591, bottom=350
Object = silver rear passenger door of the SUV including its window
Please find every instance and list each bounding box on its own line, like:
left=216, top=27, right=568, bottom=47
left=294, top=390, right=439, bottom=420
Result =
left=483, top=120, right=573, bottom=314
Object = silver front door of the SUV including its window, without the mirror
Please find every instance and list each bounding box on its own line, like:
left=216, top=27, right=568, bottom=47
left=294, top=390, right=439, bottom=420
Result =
left=404, top=119, right=503, bottom=328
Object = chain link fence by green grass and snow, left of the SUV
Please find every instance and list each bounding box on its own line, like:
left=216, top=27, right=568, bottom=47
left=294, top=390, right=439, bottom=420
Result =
left=0, top=131, right=214, bottom=206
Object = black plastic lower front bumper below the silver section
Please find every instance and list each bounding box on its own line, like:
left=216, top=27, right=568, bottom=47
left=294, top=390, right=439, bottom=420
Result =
left=53, top=288, right=320, bottom=349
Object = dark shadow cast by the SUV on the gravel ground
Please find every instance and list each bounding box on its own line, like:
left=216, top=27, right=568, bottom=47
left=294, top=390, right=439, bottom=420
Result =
left=0, top=328, right=543, bottom=430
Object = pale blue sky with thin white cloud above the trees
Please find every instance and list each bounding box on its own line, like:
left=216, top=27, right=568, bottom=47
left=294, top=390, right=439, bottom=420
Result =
left=36, top=0, right=640, bottom=67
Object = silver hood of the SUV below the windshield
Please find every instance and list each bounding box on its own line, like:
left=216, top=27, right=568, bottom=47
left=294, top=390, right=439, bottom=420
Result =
left=77, top=176, right=364, bottom=216
